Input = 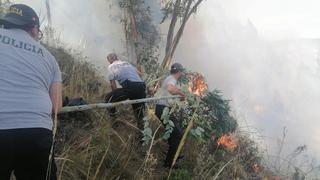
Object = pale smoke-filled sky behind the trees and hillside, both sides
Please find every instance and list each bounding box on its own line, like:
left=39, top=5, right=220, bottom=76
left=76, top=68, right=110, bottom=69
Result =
left=10, top=0, right=320, bottom=170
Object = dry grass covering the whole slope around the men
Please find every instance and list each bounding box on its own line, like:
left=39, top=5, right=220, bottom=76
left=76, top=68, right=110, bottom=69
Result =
left=49, top=44, right=320, bottom=180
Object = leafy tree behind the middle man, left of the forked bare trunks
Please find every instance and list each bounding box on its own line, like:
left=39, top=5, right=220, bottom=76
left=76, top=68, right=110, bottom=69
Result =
left=118, top=0, right=160, bottom=69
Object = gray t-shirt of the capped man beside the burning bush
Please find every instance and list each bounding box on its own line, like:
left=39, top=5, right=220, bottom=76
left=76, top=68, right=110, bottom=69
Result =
left=158, top=75, right=177, bottom=107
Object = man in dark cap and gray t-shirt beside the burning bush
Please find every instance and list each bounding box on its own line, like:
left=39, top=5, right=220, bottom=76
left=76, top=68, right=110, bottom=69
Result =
left=155, top=63, right=185, bottom=168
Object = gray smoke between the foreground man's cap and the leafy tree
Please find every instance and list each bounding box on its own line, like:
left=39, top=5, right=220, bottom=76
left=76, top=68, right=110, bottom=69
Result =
left=14, top=0, right=125, bottom=72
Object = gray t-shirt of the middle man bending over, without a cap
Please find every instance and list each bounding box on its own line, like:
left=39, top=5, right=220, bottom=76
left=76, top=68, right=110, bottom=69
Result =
left=108, top=60, right=143, bottom=84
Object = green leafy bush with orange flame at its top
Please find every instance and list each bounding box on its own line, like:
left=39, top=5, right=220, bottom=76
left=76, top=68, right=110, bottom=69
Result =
left=165, top=73, right=238, bottom=142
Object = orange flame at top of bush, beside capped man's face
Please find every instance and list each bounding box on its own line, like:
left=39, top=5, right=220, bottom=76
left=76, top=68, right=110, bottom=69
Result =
left=189, top=75, right=208, bottom=96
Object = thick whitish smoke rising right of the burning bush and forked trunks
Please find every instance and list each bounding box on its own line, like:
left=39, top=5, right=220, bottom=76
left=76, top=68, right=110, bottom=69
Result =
left=175, top=1, right=320, bottom=158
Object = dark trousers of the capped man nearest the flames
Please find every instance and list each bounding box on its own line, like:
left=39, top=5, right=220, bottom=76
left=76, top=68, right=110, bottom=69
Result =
left=156, top=105, right=183, bottom=167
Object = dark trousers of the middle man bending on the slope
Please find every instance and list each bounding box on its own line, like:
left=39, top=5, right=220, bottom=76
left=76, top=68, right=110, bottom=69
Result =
left=105, top=82, right=146, bottom=130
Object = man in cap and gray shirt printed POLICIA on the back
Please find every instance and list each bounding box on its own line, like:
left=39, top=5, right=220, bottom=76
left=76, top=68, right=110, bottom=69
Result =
left=0, top=4, right=62, bottom=180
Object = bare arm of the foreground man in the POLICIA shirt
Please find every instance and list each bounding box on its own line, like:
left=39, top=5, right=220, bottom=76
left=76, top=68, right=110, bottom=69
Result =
left=49, top=82, right=62, bottom=113
